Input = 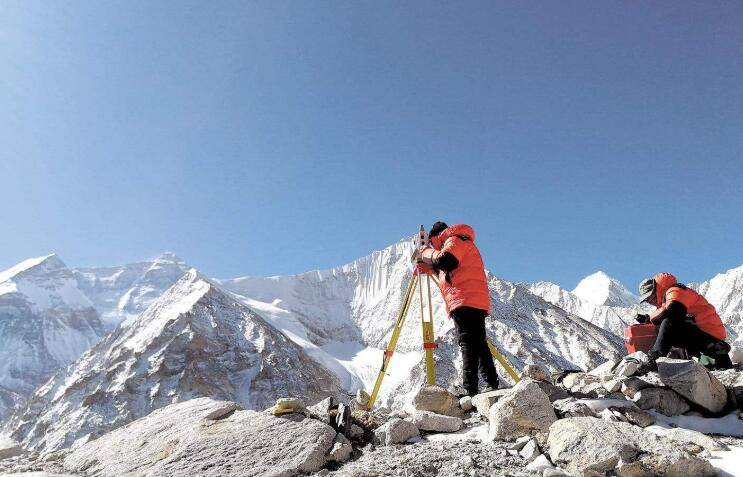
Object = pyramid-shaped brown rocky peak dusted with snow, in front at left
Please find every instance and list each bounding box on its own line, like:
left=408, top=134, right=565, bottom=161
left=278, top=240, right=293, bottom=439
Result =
left=6, top=270, right=340, bottom=449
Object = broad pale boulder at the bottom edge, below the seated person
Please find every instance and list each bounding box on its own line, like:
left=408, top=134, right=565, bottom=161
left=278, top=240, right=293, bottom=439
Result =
left=547, top=417, right=715, bottom=477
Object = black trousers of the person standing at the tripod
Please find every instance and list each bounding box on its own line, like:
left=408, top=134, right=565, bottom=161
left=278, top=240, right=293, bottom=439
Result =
left=451, top=306, right=498, bottom=396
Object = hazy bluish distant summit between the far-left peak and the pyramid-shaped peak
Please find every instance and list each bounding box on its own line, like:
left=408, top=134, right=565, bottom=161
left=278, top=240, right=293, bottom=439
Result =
left=73, top=252, right=189, bottom=330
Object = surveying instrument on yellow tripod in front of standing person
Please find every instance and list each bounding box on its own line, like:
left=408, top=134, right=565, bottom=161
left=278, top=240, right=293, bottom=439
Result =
left=366, top=225, right=519, bottom=410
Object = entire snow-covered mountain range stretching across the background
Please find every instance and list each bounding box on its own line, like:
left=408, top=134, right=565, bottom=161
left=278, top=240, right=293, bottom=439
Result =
left=0, top=240, right=743, bottom=449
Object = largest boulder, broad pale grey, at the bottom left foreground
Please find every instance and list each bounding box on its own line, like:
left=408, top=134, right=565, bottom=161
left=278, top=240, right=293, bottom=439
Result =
left=64, top=398, right=336, bottom=477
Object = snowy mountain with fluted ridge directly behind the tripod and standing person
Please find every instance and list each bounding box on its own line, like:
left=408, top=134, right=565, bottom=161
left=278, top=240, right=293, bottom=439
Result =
left=218, top=240, right=623, bottom=406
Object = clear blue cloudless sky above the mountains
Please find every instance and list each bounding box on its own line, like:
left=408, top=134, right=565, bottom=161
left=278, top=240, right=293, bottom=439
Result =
left=0, top=0, right=743, bottom=289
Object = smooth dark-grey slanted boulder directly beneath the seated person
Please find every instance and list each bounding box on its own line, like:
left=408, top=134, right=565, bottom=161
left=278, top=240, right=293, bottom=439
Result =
left=656, top=358, right=728, bottom=413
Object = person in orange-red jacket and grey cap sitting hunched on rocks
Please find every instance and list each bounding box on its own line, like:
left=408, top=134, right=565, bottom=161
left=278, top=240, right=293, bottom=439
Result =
left=637, top=273, right=732, bottom=368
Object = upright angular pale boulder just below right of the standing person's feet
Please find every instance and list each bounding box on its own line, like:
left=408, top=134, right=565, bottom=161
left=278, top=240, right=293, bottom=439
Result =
left=488, top=379, right=557, bottom=440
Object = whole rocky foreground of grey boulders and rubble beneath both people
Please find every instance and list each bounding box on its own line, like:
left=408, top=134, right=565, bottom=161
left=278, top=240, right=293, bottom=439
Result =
left=0, top=353, right=743, bottom=477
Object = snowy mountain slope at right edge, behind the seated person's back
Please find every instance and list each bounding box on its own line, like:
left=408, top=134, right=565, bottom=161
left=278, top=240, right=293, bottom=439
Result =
left=689, top=265, right=743, bottom=346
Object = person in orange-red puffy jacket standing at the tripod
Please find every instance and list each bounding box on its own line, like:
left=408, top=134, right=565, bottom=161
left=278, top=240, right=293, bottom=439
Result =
left=418, top=222, right=498, bottom=396
